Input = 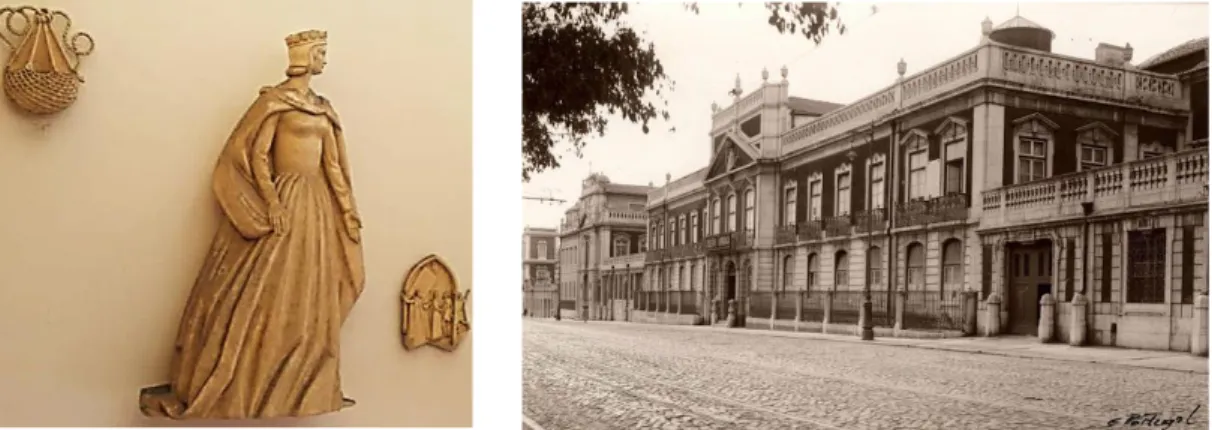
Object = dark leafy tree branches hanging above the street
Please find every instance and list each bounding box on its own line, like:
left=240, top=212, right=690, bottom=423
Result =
left=522, top=2, right=846, bottom=182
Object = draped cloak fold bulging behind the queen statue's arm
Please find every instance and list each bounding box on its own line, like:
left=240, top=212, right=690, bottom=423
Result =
left=212, top=87, right=291, bottom=240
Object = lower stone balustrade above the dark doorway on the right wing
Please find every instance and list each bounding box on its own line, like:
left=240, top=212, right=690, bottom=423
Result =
left=981, top=148, right=1208, bottom=228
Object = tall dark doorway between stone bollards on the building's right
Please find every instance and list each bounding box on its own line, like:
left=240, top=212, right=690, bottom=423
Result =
left=1006, top=240, right=1052, bottom=336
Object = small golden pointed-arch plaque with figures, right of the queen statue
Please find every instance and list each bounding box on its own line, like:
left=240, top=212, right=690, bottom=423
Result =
left=400, top=254, right=471, bottom=351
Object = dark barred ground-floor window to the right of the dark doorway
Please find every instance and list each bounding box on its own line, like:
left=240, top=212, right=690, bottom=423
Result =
left=1127, top=229, right=1166, bottom=303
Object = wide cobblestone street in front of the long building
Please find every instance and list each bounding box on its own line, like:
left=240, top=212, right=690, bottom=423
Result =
left=522, top=319, right=1208, bottom=430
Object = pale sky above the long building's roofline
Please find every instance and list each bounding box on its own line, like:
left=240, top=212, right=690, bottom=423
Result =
left=522, top=2, right=1208, bottom=231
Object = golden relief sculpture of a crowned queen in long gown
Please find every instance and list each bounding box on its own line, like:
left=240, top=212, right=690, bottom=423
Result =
left=139, top=30, right=365, bottom=419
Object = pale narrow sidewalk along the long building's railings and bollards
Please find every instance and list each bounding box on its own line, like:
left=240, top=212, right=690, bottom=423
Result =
left=686, top=326, right=1208, bottom=374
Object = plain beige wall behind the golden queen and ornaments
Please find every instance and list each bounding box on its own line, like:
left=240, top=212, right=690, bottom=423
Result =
left=0, top=0, right=475, bottom=426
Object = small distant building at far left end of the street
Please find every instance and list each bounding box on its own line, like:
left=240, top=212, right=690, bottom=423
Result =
left=522, top=227, right=560, bottom=317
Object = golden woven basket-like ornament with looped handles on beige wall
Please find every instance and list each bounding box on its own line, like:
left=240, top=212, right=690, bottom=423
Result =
left=0, top=6, right=93, bottom=115
